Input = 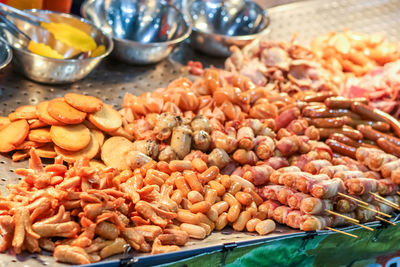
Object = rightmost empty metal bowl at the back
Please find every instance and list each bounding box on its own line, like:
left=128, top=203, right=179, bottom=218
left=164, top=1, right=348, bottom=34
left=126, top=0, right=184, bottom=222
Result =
left=189, top=0, right=269, bottom=57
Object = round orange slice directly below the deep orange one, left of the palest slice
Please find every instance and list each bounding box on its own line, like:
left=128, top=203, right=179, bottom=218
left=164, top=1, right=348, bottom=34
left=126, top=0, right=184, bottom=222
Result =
left=50, top=124, right=91, bottom=151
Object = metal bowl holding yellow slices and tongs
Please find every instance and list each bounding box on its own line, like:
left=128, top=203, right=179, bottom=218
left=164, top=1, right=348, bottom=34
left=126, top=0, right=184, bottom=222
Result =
left=0, top=9, right=113, bottom=84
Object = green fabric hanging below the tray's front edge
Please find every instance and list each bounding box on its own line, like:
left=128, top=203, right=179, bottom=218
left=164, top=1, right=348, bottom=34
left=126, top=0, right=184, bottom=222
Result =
left=164, top=226, right=400, bottom=267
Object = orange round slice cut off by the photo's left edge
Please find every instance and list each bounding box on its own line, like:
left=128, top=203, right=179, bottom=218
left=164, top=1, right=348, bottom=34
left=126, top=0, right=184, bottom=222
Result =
left=0, top=120, right=29, bottom=152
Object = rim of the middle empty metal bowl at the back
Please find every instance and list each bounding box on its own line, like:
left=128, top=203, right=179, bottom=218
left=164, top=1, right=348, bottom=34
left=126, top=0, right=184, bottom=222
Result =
left=80, top=0, right=193, bottom=47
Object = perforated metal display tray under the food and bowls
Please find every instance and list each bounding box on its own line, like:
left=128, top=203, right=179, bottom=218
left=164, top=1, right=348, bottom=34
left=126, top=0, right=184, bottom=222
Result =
left=0, top=0, right=400, bottom=267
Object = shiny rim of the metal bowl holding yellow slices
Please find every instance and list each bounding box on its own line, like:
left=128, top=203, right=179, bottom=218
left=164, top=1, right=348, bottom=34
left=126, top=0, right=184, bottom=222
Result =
left=3, top=9, right=114, bottom=63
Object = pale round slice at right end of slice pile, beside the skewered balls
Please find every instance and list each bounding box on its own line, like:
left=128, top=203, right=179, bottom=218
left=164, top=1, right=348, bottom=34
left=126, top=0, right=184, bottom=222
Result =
left=101, top=136, right=134, bottom=170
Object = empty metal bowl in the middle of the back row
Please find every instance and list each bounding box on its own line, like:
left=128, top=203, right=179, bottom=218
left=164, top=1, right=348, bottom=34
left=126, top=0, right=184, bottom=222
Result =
left=81, top=0, right=192, bottom=64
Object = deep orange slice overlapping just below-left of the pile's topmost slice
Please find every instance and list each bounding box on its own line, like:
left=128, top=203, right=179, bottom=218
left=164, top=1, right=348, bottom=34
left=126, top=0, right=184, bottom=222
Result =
left=47, top=98, right=86, bottom=124
